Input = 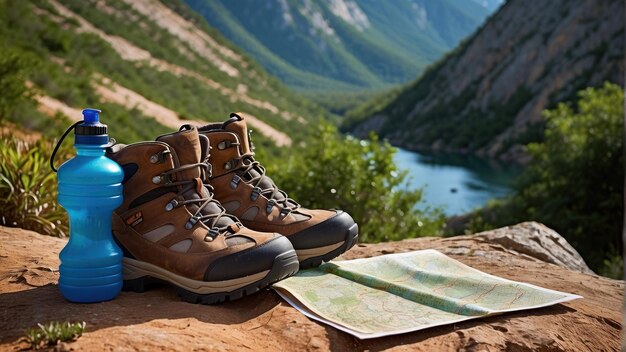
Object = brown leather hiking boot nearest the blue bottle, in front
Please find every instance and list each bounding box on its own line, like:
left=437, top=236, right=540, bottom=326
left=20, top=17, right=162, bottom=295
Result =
left=107, top=126, right=298, bottom=304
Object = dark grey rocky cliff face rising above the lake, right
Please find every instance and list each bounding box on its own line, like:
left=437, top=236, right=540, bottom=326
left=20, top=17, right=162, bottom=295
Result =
left=345, top=0, right=625, bottom=158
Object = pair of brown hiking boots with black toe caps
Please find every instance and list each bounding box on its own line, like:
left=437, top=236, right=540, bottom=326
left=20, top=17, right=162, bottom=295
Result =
left=106, top=114, right=358, bottom=304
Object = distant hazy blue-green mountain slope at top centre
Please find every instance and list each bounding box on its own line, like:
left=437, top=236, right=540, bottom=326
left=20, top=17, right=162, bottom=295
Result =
left=185, top=0, right=489, bottom=92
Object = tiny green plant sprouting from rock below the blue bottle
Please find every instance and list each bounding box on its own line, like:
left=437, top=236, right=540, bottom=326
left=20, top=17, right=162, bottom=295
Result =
left=25, top=321, right=87, bottom=349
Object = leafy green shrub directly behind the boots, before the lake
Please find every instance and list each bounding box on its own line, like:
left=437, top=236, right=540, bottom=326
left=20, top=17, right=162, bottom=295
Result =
left=266, top=123, right=444, bottom=242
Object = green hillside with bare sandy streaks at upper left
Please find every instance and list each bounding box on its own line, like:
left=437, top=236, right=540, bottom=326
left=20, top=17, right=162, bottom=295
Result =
left=0, top=0, right=323, bottom=146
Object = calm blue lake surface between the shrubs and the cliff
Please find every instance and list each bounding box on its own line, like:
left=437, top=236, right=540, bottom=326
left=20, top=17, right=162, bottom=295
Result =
left=395, top=148, right=522, bottom=215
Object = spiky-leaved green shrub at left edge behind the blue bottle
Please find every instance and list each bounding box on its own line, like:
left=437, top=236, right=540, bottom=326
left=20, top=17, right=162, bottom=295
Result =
left=0, top=136, right=69, bottom=237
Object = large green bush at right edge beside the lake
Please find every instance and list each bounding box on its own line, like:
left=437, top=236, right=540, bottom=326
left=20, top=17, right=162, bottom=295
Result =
left=473, top=83, right=624, bottom=275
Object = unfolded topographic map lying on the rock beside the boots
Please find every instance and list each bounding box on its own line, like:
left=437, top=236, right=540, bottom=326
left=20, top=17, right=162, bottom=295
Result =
left=273, top=250, right=582, bottom=339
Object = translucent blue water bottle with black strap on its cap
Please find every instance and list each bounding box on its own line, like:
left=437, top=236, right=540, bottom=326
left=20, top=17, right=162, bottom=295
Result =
left=50, top=109, right=124, bottom=303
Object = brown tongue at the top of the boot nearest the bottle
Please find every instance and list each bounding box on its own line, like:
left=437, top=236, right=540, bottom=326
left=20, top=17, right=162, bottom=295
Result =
left=157, top=128, right=202, bottom=181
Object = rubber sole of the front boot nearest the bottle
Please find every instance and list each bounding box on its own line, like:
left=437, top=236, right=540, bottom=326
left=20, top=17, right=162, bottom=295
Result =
left=122, top=250, right=299, bottom=304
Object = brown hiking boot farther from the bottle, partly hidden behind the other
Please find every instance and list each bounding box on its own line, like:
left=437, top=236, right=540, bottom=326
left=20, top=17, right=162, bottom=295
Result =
left=198, top=113, right=359, bottom=269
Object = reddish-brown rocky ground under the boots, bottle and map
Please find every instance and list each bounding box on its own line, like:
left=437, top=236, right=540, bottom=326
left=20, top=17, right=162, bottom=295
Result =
left=0, top=223, right=624, bottom=351
